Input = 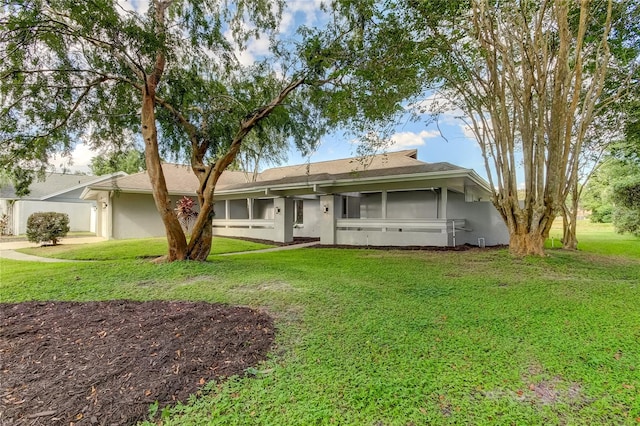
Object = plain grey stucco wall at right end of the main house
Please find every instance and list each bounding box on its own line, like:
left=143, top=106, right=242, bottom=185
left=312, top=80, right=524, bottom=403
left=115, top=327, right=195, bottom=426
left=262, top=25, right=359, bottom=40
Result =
left=447, top=192, right=509, bottom=246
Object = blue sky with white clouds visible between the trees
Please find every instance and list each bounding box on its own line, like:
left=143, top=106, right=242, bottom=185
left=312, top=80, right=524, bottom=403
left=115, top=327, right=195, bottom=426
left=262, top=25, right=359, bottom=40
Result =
left=53, top=0, right=486, bottom=178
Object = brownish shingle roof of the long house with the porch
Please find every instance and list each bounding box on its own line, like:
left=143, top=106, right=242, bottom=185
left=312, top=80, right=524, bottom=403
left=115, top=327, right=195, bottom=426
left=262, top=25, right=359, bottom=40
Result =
left=83, top=150, right=488, bottom=198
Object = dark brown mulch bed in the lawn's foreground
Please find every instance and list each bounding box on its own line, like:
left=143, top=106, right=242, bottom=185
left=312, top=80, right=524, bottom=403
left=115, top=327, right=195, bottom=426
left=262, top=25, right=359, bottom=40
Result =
left=0, top=300, right=274, bottom=426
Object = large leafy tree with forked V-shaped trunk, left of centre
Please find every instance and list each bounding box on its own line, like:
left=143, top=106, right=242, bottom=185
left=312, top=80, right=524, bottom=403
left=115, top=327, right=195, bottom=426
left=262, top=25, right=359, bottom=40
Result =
left=0, top=0, right=420, bottom=260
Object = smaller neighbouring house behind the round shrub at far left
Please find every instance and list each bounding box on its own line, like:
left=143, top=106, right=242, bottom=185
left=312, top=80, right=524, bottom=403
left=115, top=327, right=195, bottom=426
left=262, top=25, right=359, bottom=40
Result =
left=0, top=172, right=126, bottom=235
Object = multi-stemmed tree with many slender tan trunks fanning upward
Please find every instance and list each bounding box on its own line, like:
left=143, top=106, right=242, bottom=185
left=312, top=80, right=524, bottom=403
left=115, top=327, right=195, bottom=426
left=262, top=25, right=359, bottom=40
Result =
left=398, top=0, right=638, bottom=255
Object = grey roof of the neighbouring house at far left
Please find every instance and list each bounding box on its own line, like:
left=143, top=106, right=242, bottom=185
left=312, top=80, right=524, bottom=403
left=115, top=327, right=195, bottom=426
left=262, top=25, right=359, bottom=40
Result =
left=0, top=172, right=126, bottom=201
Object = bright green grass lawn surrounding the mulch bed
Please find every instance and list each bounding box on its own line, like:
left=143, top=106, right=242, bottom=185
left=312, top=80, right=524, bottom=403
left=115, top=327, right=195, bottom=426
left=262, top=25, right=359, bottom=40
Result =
left=0, top=225, right=640, bottom=425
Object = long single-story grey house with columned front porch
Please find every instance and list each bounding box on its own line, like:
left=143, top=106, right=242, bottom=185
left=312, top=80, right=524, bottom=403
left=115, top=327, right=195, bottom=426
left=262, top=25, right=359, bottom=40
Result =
left=82, top=150, right=509, bottom=246
